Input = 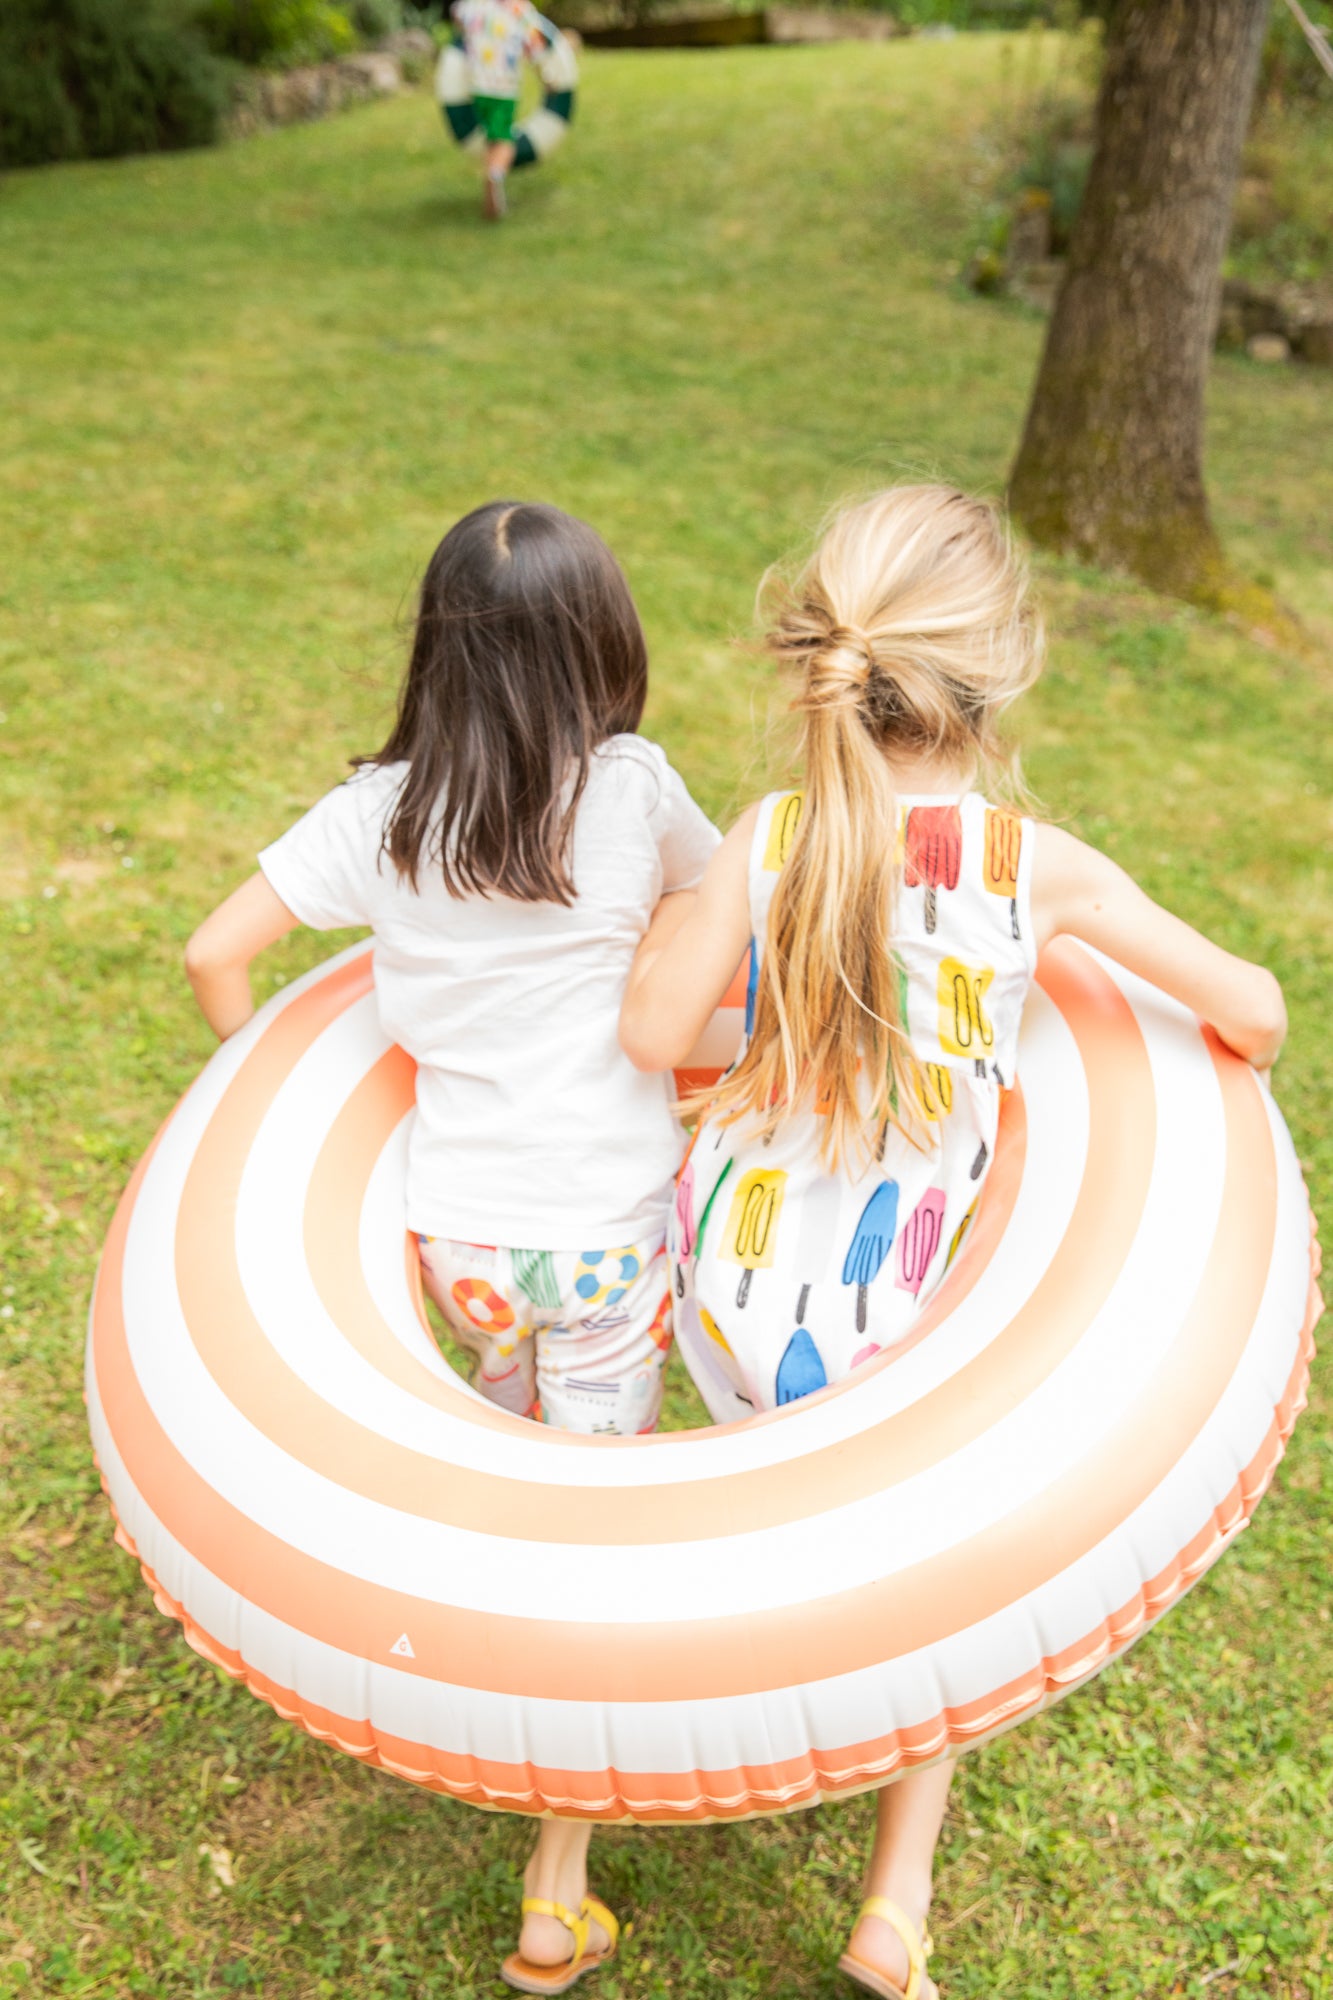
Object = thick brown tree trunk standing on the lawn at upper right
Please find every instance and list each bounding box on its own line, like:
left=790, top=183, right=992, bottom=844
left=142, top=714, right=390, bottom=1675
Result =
left=1011, top=0, right=1269, bottom=604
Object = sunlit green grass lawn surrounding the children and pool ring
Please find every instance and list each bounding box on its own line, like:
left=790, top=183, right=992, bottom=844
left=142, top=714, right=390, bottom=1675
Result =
left=0, top=36, right=1333, bottom=2000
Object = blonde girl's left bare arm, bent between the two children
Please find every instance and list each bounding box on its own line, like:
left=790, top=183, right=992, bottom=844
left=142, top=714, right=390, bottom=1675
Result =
left=620, top=806, right=759, bottom=1070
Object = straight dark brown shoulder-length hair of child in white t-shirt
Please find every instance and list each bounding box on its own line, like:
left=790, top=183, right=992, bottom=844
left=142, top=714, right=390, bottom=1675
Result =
left=354, top=500, right=648, bottom=904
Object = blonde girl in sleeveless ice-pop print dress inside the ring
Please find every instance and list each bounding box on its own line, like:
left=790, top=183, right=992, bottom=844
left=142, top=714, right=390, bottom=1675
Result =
left=620, top=486, right=1285, bottom=2000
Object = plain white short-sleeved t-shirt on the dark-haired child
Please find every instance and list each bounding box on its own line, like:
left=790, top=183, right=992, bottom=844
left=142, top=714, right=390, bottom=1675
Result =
left=258, top=736, right=721, bottom=1250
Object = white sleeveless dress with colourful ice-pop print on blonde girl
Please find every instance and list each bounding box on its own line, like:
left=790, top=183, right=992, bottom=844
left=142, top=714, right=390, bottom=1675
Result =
left=671, top=792, right=1037, bottom=1422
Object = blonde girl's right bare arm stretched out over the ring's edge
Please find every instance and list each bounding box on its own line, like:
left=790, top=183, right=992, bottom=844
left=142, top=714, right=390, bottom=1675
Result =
left=1033, top=826, right=1287, bottom=1070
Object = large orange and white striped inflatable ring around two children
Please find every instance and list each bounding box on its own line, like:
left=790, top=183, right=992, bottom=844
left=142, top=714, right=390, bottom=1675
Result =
left=86, top=942, right=1319, bottom=1820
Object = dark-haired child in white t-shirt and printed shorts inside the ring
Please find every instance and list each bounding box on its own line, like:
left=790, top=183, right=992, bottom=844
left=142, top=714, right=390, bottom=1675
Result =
left=186, top=500, right=719, bottom=2000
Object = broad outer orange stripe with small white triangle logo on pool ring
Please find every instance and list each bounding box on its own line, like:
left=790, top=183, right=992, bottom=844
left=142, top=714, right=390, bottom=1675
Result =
left=85, top=948, right=1275, bottom=1700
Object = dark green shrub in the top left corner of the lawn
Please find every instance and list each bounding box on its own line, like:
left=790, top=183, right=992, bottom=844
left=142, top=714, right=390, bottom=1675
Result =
left=0, top=0, right=228, bottom=166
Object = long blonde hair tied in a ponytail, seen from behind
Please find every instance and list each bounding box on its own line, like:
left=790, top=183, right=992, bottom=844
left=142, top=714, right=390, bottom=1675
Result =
left=707, top=486, right=1041, bottom=1166
